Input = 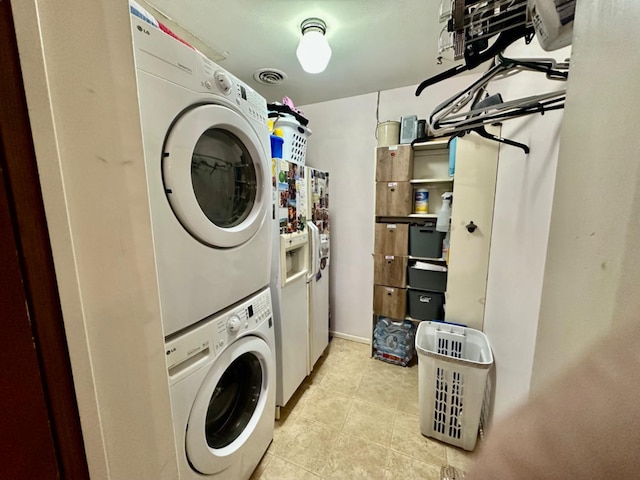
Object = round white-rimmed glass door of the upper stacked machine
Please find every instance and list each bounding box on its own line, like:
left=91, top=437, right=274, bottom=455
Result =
left=162, top=104, right=269, bottom=248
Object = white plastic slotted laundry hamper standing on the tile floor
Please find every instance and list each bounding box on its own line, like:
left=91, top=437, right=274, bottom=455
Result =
left=416, top=321, right=493, bottom=451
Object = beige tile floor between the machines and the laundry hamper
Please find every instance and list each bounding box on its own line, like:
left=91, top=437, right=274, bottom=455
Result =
left=251, top=338, right=472, bottom=480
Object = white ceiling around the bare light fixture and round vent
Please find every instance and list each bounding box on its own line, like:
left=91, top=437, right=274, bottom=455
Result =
left=141, top=0, right=454, bottom=105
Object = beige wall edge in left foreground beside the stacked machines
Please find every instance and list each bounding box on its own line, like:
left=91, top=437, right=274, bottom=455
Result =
left=12, top=0, right=177, bottom=480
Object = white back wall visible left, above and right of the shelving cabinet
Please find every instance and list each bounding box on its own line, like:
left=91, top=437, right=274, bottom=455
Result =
left=302, top=38, right=570, bottom=416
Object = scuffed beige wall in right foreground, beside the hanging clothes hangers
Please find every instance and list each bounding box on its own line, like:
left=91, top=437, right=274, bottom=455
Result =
left=532, top=0, right=640, bottom=390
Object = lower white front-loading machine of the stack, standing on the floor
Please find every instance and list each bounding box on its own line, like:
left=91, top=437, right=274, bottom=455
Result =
left=166, top=288, right=276, bottom=480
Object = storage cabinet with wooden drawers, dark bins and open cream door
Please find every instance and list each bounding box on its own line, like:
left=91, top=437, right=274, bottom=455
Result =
left=372, top=129, right=498, bottom=355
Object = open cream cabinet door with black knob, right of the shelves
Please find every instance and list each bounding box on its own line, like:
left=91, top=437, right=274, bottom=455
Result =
left=446, top=127, right=499, bottom=330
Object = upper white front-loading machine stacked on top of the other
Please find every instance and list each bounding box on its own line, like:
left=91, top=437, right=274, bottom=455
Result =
left=131, top=16, right=272, bottom=337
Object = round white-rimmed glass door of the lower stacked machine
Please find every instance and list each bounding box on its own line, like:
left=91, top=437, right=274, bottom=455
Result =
left=185, top=336, right=275, bottom=475
